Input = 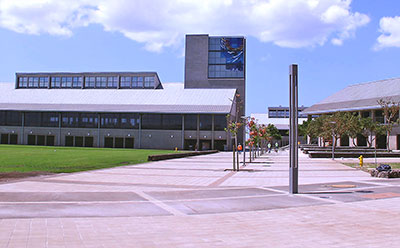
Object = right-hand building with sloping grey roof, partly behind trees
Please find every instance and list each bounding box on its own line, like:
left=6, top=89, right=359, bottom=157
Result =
left=303, top=78, right=400, bottom=150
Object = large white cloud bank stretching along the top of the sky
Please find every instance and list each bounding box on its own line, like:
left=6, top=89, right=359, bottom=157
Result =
left=0, top=0, right=369, bottom=51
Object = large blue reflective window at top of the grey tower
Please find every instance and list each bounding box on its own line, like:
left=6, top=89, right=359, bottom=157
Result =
left=208, top=37, right=244, bottom=78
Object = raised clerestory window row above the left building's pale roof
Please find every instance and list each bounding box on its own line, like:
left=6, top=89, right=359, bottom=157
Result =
left=18, top=76, right=155, bottom=89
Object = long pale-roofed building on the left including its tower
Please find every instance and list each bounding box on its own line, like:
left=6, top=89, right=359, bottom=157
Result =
left=0, top=35, right=245, bottom=150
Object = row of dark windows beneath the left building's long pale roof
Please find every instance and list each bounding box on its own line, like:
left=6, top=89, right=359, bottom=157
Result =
left=0, top=111, right=226, bottom=131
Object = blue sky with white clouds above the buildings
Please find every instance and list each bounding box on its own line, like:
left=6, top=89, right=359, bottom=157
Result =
left=0, top=0, right=400, bottom=114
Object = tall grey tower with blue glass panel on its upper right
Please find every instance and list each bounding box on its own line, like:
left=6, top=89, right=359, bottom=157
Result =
left=185, top=34, right=246, bottom=143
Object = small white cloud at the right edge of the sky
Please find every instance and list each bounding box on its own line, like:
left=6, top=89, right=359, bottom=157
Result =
left=374, top=16, right=400, bottom=50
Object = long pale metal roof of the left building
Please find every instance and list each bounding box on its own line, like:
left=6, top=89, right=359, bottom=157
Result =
left=0, top=83, right=236, bottom=114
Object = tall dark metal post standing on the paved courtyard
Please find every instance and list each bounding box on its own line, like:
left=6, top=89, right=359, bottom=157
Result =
left=289, top=64, right=299, bottom=194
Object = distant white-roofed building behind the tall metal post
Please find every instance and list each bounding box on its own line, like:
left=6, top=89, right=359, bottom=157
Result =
left=251, top=106, right=307, bottom=146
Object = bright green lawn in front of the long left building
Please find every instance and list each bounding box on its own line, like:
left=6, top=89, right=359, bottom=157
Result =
left=0, top=145, right=179, bottom=173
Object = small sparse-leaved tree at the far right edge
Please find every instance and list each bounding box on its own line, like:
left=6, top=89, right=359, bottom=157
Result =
left=378, top=98, right=400, bottom=150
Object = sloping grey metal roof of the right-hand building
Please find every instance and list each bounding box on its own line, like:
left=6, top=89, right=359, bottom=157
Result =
left=302, top=78, right=400, bottom=114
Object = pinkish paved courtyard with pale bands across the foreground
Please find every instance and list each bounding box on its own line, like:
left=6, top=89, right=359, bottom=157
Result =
left=0, top=151, right=400, bottom=247
